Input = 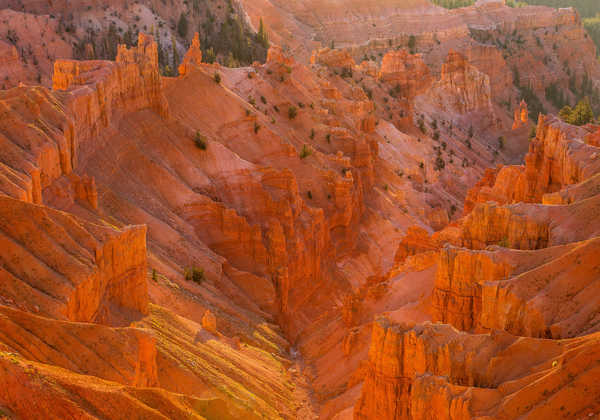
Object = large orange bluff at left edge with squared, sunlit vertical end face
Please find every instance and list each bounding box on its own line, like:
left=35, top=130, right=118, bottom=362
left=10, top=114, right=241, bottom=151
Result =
left=0, top=196, right=148, bottom=324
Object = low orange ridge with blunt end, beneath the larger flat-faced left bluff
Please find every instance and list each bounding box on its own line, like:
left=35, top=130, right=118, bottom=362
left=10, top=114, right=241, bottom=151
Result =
left=0, top=306, right=159, bottom=387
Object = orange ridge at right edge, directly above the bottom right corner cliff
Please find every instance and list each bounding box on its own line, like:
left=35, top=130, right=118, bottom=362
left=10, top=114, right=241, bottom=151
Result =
left=480, top=238, right=600, bottom=339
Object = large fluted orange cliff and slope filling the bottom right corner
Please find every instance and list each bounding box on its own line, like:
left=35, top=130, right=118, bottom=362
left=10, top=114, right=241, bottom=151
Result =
left=354, top=319, right=599, bottom=420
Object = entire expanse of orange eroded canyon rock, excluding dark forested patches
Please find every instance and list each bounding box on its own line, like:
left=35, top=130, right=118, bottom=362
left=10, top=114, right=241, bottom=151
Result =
left=0, top=0, right=600, bottom=420
